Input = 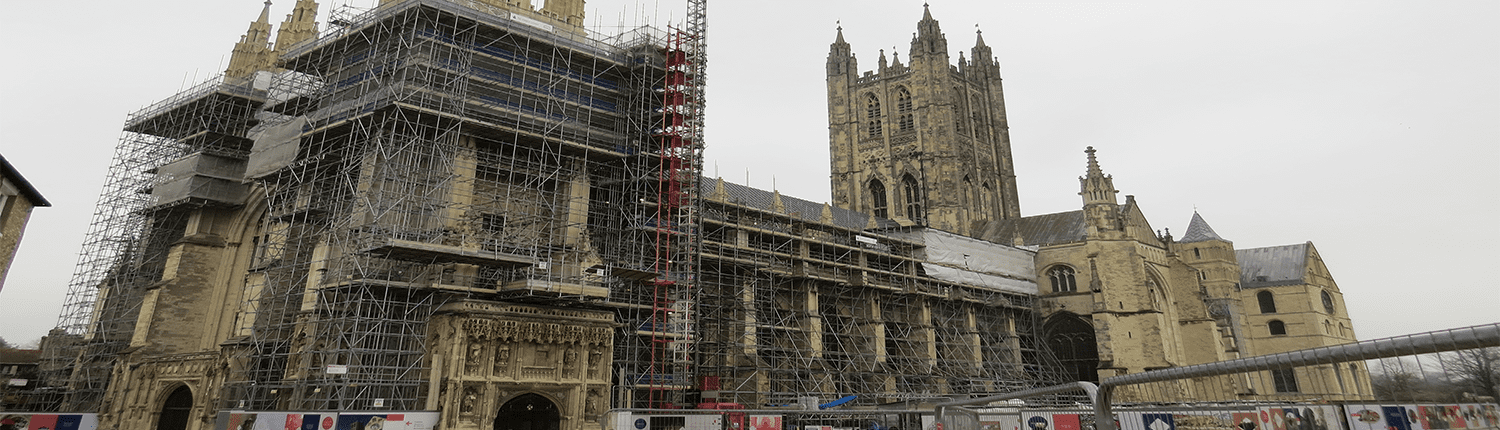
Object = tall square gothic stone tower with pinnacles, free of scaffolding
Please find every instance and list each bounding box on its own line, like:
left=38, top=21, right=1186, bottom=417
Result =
left=828, top=6, right=1020, bottom=235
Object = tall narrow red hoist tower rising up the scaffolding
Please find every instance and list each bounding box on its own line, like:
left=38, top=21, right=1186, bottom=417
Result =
left=638, top=0, right=708, bottom=408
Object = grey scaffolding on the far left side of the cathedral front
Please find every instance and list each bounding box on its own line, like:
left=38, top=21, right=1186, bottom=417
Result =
left=41, top=72, right=264, bottom=411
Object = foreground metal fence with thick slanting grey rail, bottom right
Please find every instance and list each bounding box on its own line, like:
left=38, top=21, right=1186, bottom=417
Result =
left=933, top=324, right=1500, bottom=430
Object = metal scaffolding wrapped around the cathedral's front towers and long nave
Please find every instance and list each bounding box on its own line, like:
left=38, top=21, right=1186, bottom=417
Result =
left=44, top=0, right=1059, bottom=411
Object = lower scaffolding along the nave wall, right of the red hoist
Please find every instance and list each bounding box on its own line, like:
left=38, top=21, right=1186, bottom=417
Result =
left=698, top=181, right=1064, bottom=408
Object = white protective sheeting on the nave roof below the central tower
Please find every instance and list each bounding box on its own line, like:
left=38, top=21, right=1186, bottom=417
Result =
left=893, top=228, right=1037, bottom=294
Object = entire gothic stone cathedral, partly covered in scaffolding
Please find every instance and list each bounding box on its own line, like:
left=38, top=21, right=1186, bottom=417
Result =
left=41, top=0, right=1370, bottom=430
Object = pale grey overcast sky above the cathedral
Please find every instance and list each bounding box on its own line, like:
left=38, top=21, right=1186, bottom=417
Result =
left=0, top=0, right=1500, bottom=343
